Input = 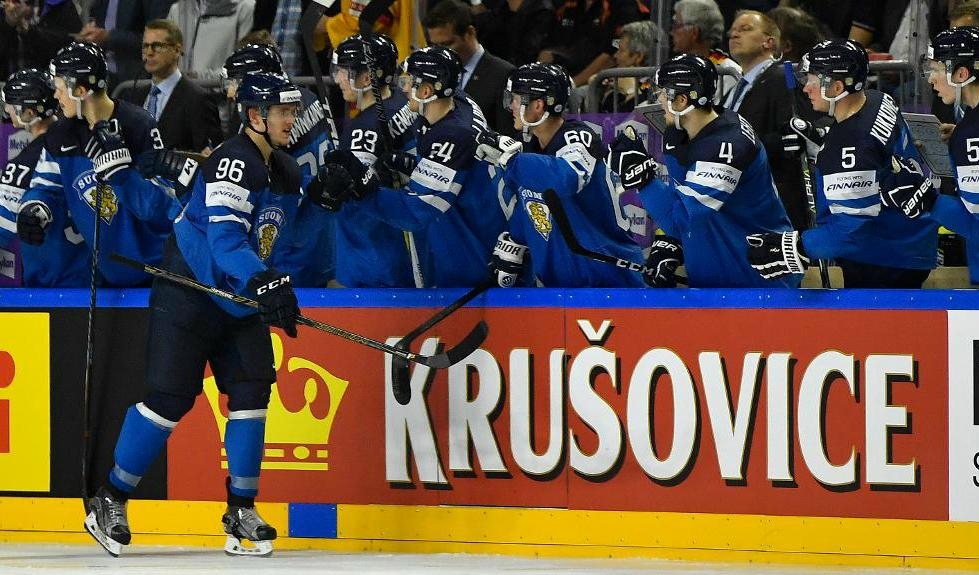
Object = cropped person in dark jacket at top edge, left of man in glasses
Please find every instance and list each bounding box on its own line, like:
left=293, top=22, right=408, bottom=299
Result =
left=78, top=0, right=173, bottom=89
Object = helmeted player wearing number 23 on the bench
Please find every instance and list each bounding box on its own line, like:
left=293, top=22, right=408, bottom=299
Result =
left=310, top=34, right=415, bottom=287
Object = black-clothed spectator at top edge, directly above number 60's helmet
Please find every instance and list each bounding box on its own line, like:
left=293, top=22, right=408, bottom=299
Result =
left=475, top=0, right=556, bottom=66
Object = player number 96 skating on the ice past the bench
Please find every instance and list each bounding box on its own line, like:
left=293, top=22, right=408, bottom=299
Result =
left=85, top=72, right=302, bottom=555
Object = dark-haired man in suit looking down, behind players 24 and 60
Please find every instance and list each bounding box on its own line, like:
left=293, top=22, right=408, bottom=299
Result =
left=425, top=0, right=516, bottom=137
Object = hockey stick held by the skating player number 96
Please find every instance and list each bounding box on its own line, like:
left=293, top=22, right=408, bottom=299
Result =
left=112, top=254, right=489, bottom=369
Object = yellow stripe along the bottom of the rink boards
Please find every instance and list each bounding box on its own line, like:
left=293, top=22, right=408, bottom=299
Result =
left=0, top=497, right=979, bottom=570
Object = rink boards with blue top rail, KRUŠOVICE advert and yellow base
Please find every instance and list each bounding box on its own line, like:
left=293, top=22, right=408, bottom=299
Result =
left=0, top=290, right=979, bottom=569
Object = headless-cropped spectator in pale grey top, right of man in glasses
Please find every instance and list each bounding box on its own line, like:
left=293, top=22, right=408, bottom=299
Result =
left=167, top=0, right=255, bottom=78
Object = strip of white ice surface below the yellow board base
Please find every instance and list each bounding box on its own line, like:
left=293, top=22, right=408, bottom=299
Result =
left=0, top=543, right=961, bottom=575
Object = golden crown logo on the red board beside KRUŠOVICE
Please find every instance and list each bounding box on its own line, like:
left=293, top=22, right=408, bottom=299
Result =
left=204, top=333, right=349, bottom=471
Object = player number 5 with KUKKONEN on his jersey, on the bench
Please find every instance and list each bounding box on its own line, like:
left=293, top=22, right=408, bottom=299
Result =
left=748, top=40, right=938, bottom=288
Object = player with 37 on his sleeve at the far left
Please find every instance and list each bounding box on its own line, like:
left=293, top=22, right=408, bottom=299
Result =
left=0, top=68, right=91, bottom=287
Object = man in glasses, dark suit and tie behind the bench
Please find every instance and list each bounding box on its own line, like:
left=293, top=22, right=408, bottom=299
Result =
left=123, top=20, right=223, bottom=152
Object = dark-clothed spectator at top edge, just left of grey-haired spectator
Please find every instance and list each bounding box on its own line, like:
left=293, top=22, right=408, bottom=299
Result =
left=538, top=0, right=649, bottom=86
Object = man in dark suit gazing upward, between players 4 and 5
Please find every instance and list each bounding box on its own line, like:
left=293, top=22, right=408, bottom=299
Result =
left=723, top=10, right=815, bottom=230
